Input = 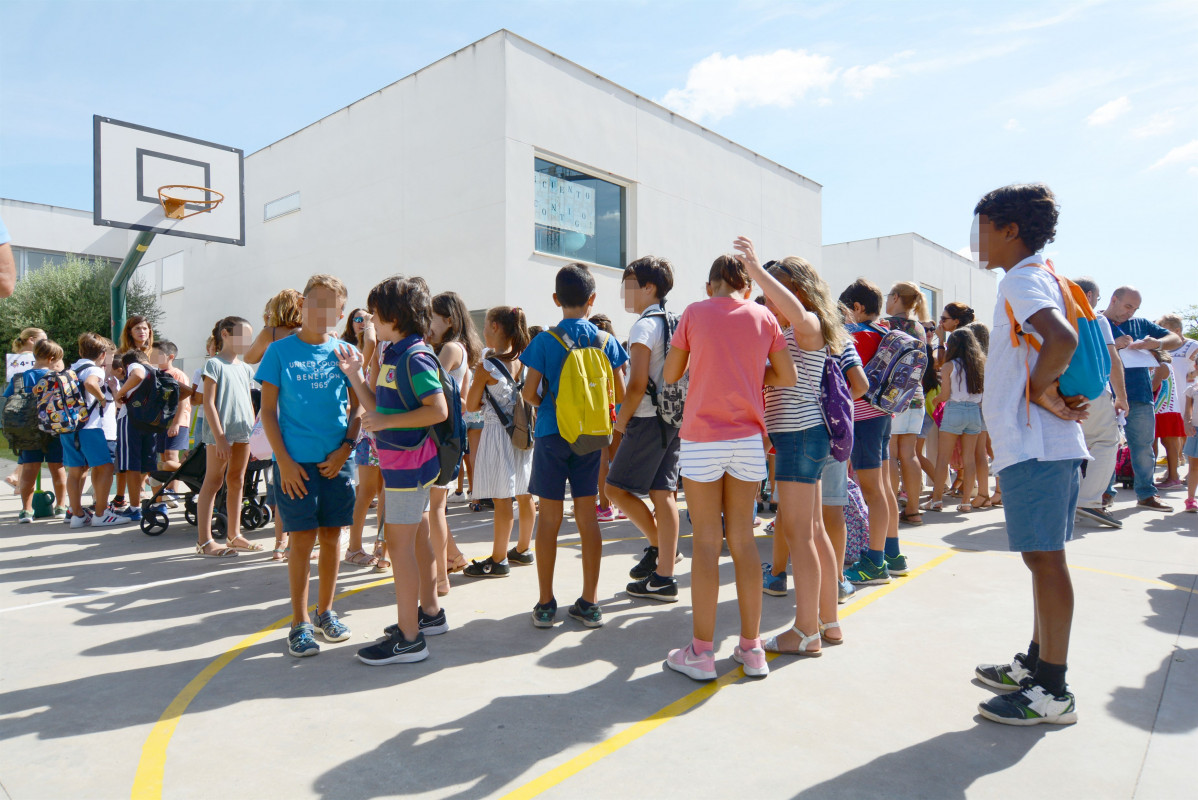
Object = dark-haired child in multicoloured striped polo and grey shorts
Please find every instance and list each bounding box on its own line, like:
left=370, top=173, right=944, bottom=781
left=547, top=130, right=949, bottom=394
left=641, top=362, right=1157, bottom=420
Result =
left=338, top=277, right=449, bottom=666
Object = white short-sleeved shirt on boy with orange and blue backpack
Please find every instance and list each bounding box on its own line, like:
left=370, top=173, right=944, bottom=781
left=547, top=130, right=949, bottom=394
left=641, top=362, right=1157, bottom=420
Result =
left=982, top=256, right=1090, bottom=473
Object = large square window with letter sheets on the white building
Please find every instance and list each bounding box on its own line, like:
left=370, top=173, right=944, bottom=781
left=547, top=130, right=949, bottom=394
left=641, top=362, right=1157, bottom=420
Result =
left=533, top=158, right=625, bottom=269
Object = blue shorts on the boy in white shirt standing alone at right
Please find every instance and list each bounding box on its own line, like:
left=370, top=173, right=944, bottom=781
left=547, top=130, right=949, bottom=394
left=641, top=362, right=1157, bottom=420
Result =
left=998, top=459, right=1082, bottom=553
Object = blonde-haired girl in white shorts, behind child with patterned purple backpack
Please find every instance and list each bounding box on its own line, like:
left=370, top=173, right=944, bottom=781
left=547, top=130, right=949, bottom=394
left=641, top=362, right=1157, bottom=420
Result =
left=887, top=280, right=931, bottom=525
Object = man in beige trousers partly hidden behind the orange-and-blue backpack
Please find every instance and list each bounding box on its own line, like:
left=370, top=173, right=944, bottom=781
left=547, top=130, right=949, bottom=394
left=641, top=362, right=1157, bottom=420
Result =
left=1073, top=278, right=1127, bottom=528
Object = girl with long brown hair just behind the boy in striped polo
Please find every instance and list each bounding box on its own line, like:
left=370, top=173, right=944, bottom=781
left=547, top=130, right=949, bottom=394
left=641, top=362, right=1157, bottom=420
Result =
left=429, top=292, right=483, bottom=595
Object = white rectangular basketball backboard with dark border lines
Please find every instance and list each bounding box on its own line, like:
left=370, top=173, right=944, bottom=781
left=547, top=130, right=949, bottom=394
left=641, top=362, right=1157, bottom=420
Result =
left=92, top=115, right=246, bottom=244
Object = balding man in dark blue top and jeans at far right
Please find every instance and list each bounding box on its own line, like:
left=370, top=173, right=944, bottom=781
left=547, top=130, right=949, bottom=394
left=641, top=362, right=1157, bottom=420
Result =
left=1103, top=286, right=1182, bottom=511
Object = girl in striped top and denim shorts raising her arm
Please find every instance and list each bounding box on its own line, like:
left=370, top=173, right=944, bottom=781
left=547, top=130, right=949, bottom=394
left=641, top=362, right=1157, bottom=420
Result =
left=752, top=250, right=847, bottom=656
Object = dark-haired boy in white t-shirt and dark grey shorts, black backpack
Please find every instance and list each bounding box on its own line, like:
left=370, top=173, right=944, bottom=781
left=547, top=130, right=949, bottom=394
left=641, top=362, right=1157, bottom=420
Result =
left=607, top=255, right=680, bottom=602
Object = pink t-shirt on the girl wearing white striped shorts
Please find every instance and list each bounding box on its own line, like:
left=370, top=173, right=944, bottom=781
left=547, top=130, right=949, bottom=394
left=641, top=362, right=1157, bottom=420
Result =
left=671, top=297, right=786, bottom=442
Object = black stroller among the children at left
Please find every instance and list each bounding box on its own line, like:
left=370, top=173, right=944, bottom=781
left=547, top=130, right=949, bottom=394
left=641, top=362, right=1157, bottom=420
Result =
left=141, top=444, right=273, bottom=540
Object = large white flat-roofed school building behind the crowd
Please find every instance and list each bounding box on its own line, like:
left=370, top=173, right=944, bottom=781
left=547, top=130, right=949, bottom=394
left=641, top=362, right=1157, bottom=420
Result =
left=5, top=30, right=994, bottom=369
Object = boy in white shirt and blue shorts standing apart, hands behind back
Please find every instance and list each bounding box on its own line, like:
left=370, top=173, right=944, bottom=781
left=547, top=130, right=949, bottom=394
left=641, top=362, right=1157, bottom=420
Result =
left=974, top=184, right=1089, bottom=725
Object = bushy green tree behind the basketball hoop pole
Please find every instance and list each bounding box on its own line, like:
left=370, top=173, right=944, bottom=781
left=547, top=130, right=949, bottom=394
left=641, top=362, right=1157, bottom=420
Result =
left=0, top=254, right=162, bottom=366
